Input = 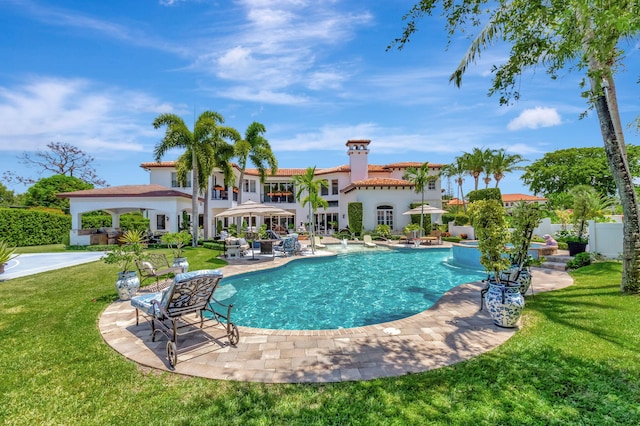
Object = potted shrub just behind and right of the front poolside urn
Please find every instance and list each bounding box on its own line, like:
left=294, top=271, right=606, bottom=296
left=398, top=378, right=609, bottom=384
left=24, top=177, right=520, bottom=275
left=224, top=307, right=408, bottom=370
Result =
left=509, top=201, right=542, bottom=295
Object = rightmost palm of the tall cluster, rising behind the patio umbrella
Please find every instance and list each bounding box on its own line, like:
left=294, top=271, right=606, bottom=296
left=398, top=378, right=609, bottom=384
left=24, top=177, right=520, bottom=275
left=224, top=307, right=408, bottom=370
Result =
left=234, top=121, right=278, bottom=204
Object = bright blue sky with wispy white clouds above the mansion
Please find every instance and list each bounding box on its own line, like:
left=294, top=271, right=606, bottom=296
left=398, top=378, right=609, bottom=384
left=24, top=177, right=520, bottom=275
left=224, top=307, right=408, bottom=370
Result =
left=0, top=0, right=640, bottom=193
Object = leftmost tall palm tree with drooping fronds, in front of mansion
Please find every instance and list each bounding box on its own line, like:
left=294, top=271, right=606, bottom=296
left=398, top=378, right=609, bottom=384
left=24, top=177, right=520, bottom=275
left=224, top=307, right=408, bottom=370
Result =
left=153, top=111, right=237, bottom=247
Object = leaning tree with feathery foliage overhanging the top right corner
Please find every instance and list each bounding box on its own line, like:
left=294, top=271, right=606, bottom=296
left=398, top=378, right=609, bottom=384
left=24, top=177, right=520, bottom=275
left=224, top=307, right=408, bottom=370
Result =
left=394, top=0, right=640, bottom=292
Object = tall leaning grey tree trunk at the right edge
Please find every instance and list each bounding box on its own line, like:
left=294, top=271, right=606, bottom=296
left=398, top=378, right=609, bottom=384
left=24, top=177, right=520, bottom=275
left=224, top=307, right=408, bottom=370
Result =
left=591, top=75, right=640, bottom=292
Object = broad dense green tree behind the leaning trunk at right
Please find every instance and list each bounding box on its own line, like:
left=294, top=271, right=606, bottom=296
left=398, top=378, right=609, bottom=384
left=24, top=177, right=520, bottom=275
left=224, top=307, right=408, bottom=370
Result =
left=521, top=145, right=640, bottom=197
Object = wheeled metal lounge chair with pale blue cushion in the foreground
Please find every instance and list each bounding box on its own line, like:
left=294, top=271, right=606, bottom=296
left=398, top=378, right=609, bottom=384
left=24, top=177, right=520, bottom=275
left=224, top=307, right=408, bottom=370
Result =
left=131, top=270, right=240, bottom=367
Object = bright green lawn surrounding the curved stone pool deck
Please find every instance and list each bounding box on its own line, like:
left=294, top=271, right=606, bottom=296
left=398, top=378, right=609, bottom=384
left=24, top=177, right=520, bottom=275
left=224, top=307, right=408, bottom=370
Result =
left=0, top=249, right=640, bottom=425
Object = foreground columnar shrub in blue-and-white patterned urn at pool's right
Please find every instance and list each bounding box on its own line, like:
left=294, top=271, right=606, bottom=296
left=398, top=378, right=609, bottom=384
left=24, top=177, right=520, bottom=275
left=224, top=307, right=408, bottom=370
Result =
left=469, top=200, right=524, bottom=328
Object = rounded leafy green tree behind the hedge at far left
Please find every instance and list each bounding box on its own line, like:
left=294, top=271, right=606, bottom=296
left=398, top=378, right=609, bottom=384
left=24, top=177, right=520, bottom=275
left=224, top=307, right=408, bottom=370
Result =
left=24, top=175, right=93, bottom=213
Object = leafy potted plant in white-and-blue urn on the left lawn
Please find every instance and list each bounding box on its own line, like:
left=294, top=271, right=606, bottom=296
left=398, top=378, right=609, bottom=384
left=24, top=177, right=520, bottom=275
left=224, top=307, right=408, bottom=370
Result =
left=102, top=230, right=144, bottom=300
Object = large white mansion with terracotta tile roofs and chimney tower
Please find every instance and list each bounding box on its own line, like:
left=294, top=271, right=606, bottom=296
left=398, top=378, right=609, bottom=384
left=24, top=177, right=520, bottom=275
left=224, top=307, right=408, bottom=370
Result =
left=59, top=140, right=442, bottom=245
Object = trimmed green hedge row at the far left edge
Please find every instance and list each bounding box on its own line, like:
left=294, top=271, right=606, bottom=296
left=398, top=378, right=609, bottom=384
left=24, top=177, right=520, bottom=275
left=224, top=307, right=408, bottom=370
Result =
left=0, top=208, right=71, bottom=247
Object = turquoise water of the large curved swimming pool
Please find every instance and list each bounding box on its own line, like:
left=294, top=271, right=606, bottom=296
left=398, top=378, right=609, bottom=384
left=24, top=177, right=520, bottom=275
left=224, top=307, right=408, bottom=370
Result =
left=215, top=249, right=485, bottom=330
